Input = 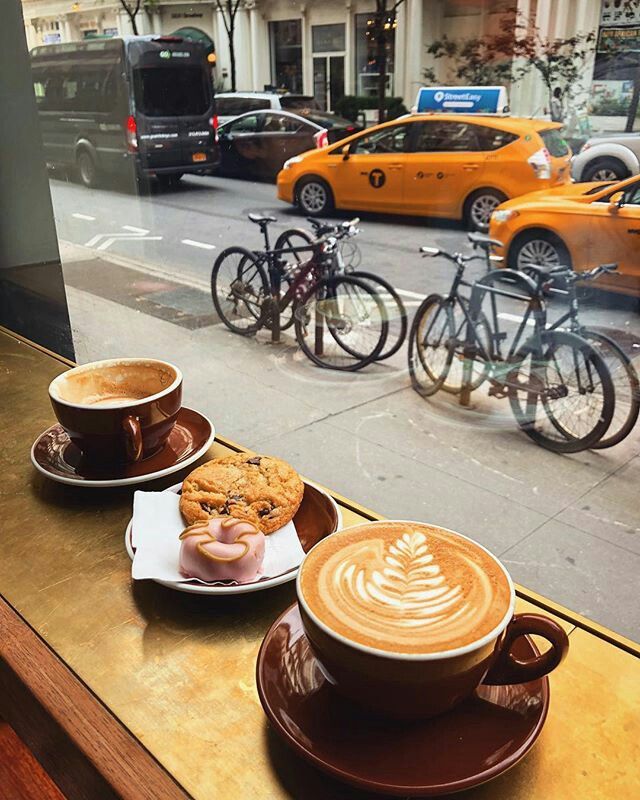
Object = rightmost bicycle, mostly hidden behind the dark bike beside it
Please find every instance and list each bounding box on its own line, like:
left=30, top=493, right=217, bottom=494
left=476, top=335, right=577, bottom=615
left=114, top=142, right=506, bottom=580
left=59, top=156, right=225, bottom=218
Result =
left=523, top=264, right=640, bottom=449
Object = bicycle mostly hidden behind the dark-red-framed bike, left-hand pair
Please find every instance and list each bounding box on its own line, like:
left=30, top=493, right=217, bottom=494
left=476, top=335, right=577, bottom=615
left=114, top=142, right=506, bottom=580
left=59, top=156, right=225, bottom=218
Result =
left=275, top=217, right=409, bottom=361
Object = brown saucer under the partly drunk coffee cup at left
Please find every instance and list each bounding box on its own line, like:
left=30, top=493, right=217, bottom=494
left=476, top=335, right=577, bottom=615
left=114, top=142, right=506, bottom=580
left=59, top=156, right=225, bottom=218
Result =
left=31, top=406, right=215, bottom=487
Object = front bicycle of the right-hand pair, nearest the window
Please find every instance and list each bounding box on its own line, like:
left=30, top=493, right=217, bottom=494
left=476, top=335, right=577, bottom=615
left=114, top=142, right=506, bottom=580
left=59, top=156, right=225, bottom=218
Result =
left=409, top=247, right=614, bottom=453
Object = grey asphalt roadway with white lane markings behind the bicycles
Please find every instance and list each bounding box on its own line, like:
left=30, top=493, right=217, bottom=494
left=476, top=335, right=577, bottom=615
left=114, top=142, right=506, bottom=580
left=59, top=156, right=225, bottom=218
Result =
left=50, top=176, right=640, bottom=335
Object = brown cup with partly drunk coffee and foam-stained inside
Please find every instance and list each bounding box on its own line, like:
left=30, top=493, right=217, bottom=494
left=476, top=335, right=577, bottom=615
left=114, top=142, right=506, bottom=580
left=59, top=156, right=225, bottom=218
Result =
left=49, top=358, right=182, bottom=466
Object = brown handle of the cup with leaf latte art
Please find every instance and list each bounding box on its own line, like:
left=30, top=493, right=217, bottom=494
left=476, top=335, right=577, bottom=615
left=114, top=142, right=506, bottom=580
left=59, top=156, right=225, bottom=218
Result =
left=483, top=614, right=569, bottom=686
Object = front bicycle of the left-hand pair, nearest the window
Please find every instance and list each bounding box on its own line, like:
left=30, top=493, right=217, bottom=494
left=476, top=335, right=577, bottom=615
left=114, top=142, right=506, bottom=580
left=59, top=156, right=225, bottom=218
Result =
left=211, top=214, right=388, bottom=371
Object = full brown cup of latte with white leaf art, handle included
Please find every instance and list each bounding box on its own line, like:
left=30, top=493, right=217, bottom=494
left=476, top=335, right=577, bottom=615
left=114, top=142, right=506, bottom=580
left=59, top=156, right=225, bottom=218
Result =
left=296, top=521, right=569, bottom=719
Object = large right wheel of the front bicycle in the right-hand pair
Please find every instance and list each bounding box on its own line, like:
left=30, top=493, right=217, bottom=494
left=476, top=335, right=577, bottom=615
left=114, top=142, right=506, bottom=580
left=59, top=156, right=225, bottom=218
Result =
left=507, top=331, right=614, bottom=453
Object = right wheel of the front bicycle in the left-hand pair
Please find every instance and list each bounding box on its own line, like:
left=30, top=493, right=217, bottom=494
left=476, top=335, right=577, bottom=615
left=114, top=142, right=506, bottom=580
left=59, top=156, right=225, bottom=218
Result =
left=294, top=275, right=389, bottom=372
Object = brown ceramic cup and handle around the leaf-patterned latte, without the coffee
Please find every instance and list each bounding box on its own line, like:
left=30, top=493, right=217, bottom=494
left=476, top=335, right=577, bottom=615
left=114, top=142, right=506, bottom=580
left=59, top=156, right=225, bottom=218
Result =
left=296, top=522, right=569, bottom=719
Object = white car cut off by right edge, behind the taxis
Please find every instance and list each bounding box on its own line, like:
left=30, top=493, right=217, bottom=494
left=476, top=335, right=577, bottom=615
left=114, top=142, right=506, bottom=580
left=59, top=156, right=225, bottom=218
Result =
left=571, top=133, right=640, bottom=181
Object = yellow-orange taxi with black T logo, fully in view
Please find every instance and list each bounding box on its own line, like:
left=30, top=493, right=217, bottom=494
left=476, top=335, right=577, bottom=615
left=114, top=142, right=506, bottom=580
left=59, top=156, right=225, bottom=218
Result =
left=278, top=113, right=571, bottom=230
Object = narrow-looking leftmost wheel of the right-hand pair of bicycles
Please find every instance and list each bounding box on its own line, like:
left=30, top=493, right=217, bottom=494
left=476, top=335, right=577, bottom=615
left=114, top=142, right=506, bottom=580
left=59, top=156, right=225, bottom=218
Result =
left=408, top=294, right=455, bottom=397
